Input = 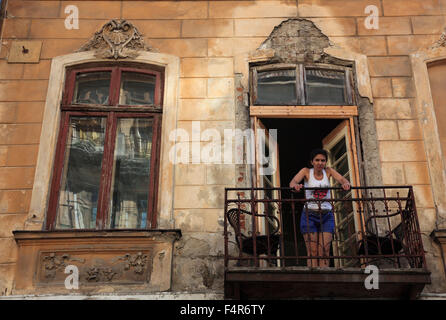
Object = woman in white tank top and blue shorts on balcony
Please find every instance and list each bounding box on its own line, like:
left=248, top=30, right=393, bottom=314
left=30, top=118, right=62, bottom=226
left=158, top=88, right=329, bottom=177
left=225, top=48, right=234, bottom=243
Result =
left=290, top=149, right=350, bottom=267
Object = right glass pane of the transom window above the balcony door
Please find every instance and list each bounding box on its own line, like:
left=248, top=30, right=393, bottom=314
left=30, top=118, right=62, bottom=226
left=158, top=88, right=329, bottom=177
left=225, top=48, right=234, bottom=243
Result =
left=305, top=69, right=346, bottom=105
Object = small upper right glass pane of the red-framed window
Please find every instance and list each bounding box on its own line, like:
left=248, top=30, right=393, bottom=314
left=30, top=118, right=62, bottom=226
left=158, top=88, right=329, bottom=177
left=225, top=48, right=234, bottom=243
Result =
left=119, top=72, right=156, bottom=105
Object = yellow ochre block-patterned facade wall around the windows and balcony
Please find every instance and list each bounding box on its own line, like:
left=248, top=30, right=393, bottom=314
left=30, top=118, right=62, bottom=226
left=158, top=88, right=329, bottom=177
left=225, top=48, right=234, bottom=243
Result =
left=0, top=0, right=446, bottom=295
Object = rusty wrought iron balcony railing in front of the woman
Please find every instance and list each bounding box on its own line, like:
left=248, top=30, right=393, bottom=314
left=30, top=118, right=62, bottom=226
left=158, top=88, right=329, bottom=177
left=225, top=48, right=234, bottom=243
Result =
left=224, top=186, right=426, bottom=269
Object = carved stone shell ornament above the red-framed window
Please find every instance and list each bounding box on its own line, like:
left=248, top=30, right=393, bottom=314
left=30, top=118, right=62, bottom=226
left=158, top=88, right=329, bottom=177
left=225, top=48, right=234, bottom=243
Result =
left=77, top=20, right=154, bottom=59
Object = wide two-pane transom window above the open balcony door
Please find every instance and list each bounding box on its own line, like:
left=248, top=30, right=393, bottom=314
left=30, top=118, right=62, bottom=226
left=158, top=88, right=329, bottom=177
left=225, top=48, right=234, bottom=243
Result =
left=251, top=64, right=353, bottom=106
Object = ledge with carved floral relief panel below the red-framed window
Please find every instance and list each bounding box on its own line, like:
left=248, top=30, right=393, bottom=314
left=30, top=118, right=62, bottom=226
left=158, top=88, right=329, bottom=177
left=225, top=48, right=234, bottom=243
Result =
left=13, top=229, right=181, bottom=295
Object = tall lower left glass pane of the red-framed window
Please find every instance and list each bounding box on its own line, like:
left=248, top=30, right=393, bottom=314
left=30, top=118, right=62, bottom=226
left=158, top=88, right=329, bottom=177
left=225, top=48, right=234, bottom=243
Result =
left=56, top=117, right=106, bottom=229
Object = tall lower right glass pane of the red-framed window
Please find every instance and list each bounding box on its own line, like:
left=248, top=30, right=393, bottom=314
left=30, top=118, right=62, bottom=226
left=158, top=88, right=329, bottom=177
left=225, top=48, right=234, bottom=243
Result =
left=110, top=118, right=153, bottom=228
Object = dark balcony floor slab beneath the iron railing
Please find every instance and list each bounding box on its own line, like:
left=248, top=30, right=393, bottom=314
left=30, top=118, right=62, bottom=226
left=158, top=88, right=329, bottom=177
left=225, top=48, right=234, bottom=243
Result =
left=225, top=267, right=431, bottom=300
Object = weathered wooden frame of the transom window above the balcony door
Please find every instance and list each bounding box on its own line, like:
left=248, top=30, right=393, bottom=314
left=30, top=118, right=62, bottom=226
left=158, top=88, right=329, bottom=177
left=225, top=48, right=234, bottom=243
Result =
left=250, top=63, right=356, bottom=107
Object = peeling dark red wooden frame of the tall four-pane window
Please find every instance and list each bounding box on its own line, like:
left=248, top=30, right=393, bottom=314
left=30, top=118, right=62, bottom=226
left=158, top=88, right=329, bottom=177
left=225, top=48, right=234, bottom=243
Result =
left=45, top=66, right=164, bottom=231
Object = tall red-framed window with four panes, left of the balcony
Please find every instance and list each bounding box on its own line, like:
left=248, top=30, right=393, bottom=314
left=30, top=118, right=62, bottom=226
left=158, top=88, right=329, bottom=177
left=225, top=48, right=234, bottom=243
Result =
left=47, top=66, right=163, bottom=230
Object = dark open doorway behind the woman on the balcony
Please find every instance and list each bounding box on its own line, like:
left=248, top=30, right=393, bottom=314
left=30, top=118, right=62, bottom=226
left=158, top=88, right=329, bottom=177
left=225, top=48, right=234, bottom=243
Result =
left=261, top=118, right=344, bottom=266
